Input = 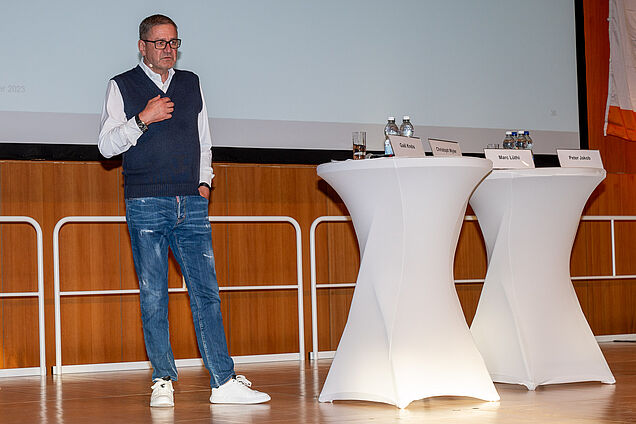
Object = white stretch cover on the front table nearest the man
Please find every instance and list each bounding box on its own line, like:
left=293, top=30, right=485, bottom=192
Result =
left=318, top=157, right=499, bottom=408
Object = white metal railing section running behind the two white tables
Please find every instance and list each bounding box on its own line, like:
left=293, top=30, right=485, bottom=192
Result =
left=309, top=215, right=636, bottom=360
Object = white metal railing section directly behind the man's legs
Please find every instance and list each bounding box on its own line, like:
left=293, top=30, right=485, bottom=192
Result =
left=53, top=216, right=305, bottom=375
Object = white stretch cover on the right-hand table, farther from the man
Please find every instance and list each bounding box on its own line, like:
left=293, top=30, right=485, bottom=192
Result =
left=470, top=168, right=615, bottom=390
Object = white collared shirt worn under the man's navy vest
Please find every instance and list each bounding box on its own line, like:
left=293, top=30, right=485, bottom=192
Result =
left=97, top=60, right=214, bottom=185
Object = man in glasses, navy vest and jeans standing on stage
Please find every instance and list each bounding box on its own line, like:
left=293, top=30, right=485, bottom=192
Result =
left=98, top=15, right=270, bottom=406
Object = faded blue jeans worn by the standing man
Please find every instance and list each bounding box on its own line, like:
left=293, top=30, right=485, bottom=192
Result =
left=126, top=196, right=234, bottom=387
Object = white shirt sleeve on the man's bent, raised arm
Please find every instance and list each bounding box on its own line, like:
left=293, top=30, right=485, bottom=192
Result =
left=97, top=80, right=142, bottom=158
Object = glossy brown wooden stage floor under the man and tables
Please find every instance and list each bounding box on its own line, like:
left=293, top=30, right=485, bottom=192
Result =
left=0, top=343, right=636, bottom=424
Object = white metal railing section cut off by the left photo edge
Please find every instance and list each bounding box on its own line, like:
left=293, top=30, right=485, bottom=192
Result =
left=0, top=216, right=46, bottom=377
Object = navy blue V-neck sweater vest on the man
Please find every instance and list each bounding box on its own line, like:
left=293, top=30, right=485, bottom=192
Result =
left=113, top=66, right=203, bottom=199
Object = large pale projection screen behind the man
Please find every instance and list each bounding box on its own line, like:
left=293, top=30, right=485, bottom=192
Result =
left=0, top=0, right=580, bottom=154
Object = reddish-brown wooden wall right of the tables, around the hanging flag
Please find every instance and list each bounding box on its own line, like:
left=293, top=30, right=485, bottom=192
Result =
left=560, top=0, right=636, bottom=334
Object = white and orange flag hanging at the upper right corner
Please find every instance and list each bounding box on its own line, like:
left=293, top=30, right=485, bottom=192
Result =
left=605, top=0, right=636, bottom=141
